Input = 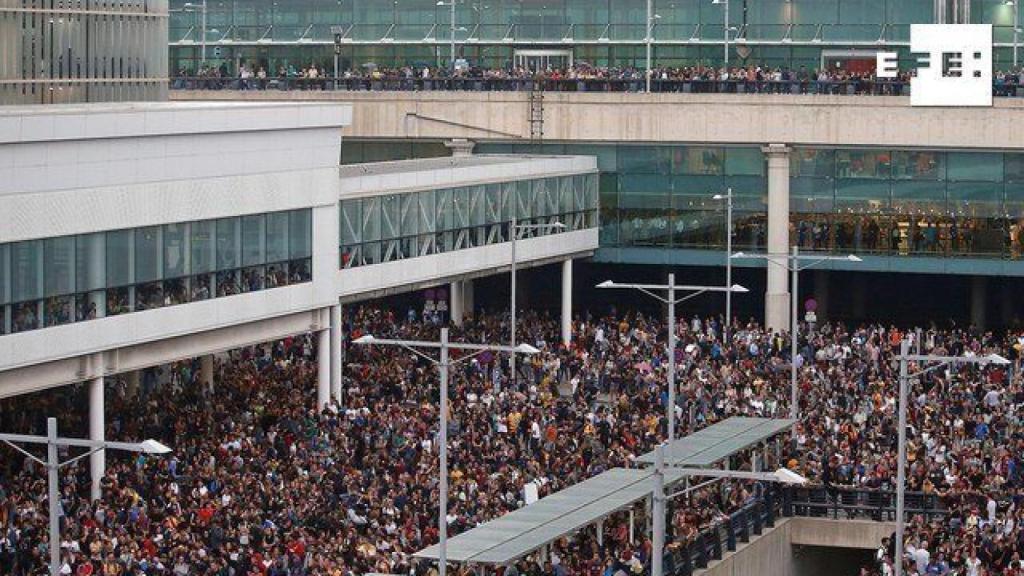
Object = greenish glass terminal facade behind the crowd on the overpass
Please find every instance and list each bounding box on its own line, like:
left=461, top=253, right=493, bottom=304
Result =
left=170, top=0, right=1014, bottom=74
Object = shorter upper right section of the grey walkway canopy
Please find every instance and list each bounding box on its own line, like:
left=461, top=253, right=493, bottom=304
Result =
left=636, top=416, right=796, bottom=467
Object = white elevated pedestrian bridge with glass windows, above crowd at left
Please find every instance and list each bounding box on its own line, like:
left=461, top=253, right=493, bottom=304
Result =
left=0, top=102, right=598, bottom=403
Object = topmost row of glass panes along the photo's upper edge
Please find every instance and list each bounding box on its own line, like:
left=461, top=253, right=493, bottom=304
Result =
left=165, top=0, right=1013, bottom=35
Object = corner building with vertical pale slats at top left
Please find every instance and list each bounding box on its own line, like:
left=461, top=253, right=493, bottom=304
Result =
left=0, top=0, right=168, bottom=105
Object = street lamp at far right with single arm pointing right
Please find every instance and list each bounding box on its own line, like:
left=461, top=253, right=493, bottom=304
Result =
left=893, top=338, right=1010, bottom=576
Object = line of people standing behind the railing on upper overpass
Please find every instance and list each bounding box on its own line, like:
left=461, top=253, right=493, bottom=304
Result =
left=171, top=63, right=1024, bottom=96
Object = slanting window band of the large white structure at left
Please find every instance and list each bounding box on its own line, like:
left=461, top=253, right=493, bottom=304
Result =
left=0, top=209, right=312, bottom=334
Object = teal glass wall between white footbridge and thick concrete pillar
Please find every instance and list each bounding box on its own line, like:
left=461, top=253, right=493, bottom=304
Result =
left=477, top=142, right=768, bottom=250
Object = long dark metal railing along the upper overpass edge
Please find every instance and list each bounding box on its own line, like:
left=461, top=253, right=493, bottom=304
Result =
left=170, top=77, right=1024, bottom=97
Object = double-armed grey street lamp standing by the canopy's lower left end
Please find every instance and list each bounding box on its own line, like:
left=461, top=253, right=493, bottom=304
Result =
left=352, top=328, right=541, bottom=576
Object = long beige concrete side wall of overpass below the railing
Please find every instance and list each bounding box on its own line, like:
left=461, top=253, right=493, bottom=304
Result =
left=171, top=90, right=1024, bottom=150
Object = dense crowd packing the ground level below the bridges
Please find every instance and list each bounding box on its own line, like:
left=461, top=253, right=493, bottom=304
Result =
left=0, top=307, right=1024, bottom=576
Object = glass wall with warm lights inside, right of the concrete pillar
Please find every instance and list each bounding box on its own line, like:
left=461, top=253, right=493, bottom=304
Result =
left=791, top=148, right=1024, bottom=258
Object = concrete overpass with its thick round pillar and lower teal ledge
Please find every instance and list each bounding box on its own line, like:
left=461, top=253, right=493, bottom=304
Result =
left=172, top=90, right=1024, bottom=330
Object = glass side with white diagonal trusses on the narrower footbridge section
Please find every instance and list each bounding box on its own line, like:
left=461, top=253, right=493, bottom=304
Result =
left=340, top=174, right=598, bottom=269
